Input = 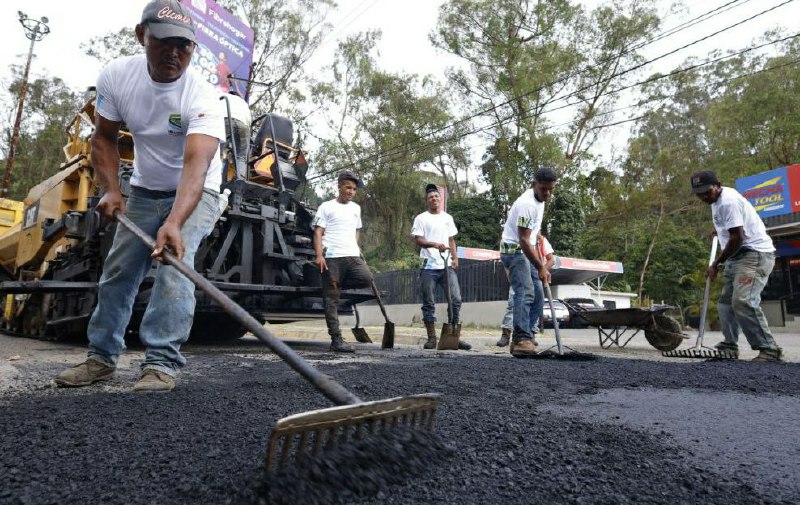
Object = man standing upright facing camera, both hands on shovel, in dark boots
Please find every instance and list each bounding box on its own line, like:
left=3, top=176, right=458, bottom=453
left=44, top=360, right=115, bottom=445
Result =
left=411, top=184, right=472, bottom=350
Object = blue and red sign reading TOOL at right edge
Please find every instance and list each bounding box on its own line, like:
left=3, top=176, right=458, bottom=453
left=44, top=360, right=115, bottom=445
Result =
left=736, top=165, right=800, bottom=219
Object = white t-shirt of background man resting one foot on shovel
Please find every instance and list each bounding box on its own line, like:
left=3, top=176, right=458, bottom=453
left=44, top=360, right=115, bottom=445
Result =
left=311, top=200, right=361, bottom=258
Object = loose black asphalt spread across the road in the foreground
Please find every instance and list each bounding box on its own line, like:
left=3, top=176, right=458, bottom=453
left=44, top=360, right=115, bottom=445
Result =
left=0, top=352, right=800, bottom=505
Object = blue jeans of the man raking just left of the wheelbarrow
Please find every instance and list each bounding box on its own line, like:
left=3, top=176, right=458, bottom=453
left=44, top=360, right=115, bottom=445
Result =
left=500, top=251, right=544, bottom=341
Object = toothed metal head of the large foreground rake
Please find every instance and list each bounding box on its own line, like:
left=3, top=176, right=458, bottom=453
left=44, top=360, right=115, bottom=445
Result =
left=266, top=393, right=441, bottom=473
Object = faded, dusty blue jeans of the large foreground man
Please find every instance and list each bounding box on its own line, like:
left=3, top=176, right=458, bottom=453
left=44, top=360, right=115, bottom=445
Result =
left=88, top=188, right=219, bottom=376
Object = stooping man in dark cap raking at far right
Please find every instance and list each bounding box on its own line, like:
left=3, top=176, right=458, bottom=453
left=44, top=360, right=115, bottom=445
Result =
left=691, top=170, right=783, bottom=361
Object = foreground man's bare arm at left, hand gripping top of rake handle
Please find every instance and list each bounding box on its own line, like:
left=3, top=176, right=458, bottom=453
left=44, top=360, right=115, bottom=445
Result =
left=92, top=114, right=125, bottom=219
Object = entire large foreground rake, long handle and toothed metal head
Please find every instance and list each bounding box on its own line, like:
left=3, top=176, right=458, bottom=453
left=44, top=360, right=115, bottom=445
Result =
left=114, top=211, right=441, bottom=473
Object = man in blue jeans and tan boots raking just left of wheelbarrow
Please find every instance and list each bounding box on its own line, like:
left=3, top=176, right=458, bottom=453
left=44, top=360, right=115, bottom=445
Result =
left=500, top=168, right=558, bottom=357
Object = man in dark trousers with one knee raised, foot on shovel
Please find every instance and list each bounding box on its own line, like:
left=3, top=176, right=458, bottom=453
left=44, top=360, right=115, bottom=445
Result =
left=312, top=170, right=372, bottom=352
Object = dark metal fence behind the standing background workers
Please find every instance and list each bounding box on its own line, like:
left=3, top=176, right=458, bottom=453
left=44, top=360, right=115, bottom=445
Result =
left=375, top=261, right=508, bottom=305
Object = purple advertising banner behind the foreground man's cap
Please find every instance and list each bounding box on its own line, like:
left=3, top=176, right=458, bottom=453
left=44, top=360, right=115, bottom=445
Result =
left=181, top=0, right=253, bottom=100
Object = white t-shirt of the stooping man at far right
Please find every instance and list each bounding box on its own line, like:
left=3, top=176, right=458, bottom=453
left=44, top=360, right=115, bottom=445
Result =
left=711, top=186, right=775, bottom=252
